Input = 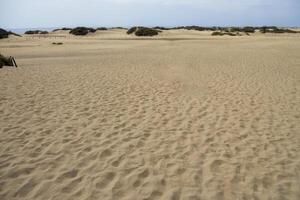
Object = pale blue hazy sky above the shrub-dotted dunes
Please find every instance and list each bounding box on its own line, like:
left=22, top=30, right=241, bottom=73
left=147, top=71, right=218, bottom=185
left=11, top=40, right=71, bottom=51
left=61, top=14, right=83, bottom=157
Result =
left=0, top=0, right=300, bottom=29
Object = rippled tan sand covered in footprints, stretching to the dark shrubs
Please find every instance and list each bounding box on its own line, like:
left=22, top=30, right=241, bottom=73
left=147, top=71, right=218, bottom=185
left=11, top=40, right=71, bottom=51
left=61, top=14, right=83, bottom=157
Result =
left=0, top=30, right=300, bottom=200
